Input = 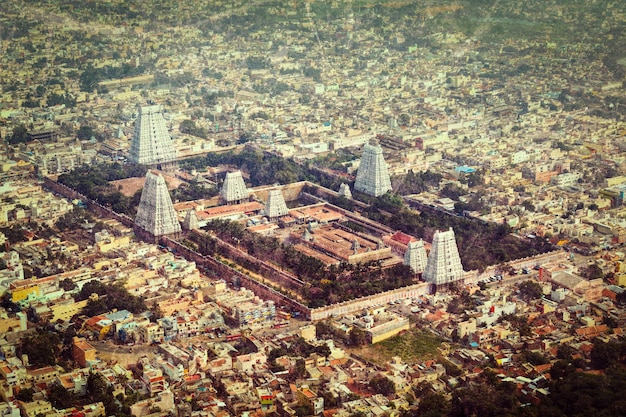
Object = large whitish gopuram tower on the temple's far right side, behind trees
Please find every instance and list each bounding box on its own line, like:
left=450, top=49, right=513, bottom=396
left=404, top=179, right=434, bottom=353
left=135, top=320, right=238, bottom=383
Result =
left=354, top=139, right=391, bottom=197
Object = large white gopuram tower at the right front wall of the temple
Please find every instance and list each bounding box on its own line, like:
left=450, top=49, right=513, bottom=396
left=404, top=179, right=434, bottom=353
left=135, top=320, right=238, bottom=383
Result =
left=422, top=228, right=464, bottom=289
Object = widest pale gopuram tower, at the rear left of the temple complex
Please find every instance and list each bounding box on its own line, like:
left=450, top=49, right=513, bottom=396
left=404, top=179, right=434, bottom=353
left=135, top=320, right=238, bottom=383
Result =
left=128, top=105, right=176, bottom=170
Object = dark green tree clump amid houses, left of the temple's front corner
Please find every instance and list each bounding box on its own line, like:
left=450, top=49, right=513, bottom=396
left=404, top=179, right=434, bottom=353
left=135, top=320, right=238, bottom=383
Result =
left=74, top=280, right=148, bottom=317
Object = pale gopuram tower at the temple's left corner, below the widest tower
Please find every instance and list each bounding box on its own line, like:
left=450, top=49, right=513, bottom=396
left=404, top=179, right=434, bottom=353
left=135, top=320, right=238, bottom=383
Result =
left=134, top=171, right=181, bottom=243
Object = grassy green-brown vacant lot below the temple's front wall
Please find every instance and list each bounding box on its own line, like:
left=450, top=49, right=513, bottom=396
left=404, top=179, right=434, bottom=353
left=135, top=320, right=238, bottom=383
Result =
left=353, top=328, right=441, bottom=365
